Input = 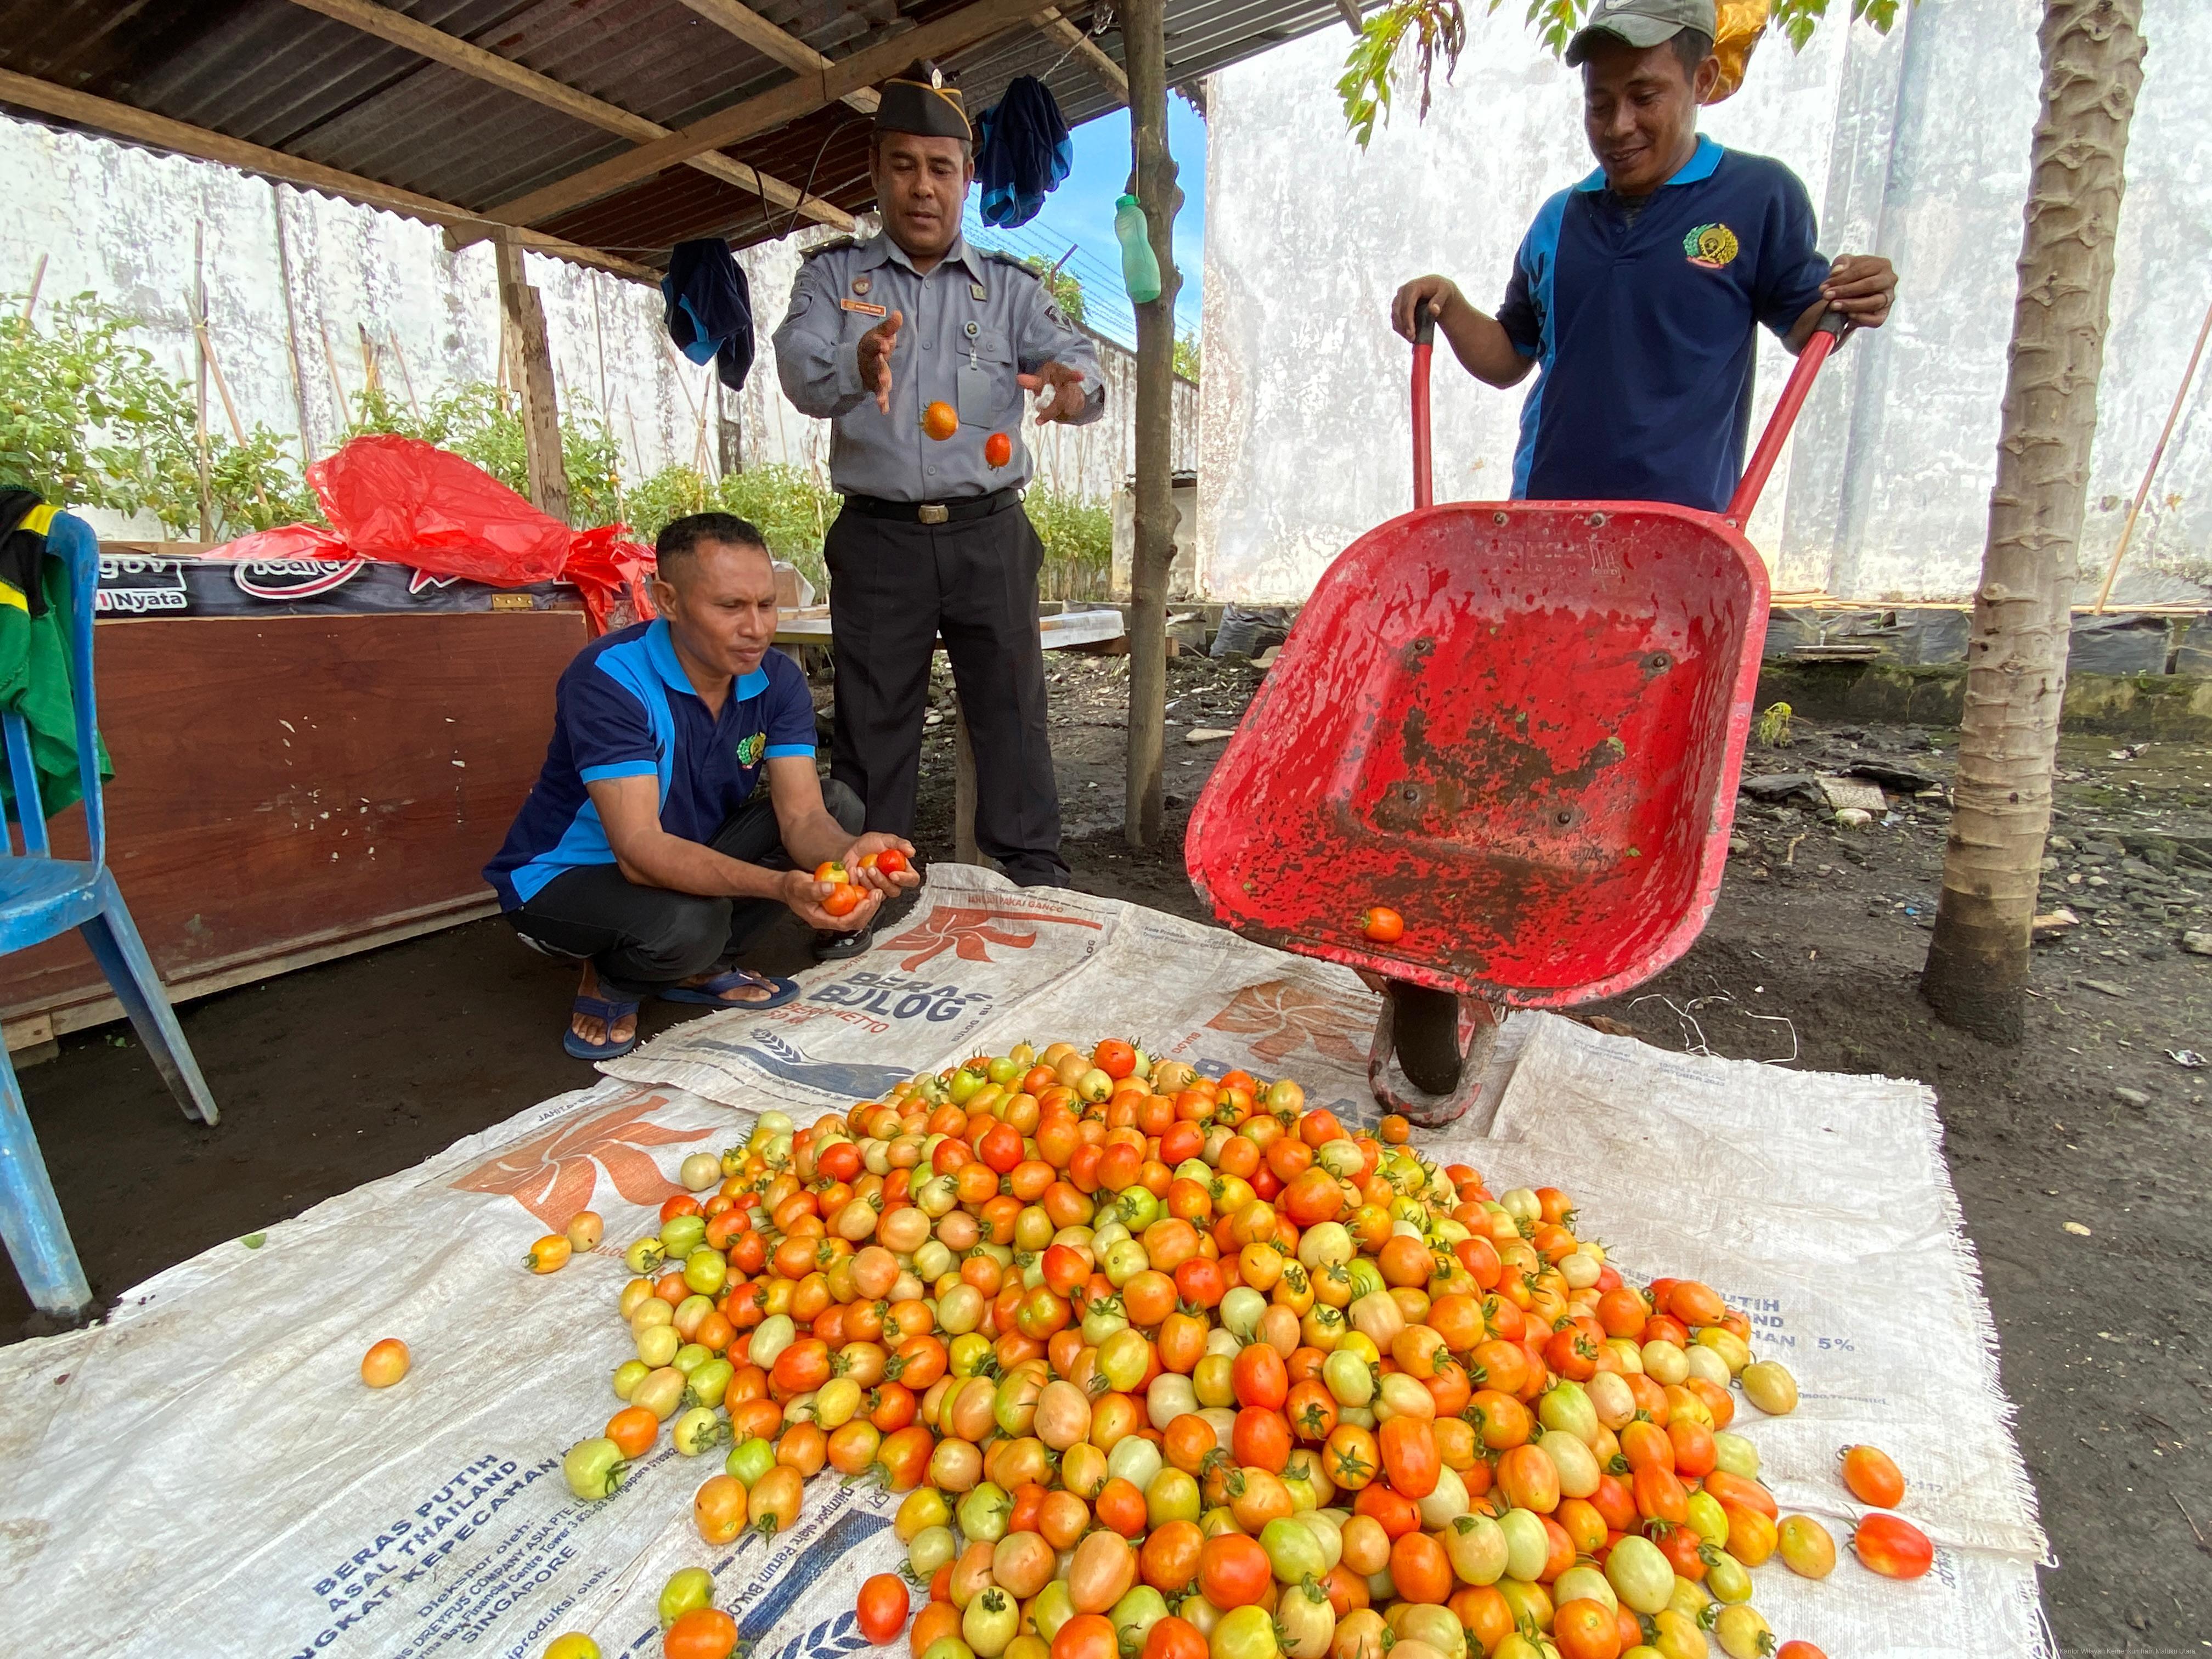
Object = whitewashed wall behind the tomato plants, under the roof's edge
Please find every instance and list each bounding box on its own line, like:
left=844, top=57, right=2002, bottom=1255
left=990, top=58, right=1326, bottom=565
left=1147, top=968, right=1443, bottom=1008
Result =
left=0, top=117, right=1197, bottom=535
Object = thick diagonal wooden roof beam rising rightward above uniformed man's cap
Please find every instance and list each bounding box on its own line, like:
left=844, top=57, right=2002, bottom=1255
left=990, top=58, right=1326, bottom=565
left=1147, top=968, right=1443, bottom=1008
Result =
left=473, top=0, right=1037, bottom=239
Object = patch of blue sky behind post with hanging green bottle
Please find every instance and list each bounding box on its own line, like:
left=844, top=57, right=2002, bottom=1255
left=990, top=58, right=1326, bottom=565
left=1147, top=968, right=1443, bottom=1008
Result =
left=967, top=95, right=1205, bottom=345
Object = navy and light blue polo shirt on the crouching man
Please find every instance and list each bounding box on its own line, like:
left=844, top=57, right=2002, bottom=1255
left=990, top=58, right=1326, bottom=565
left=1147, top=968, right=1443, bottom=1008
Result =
left=484, top=622, right=814, bottom=909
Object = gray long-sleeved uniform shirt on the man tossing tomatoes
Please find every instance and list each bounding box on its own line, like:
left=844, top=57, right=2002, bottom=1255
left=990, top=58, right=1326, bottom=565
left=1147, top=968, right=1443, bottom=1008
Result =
left=776, top=234, right=1106, bottom=502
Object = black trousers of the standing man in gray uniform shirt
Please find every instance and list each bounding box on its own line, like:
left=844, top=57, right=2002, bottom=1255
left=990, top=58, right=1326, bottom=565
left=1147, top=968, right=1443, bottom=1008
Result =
left=823, top=504, right=1068, bottom=887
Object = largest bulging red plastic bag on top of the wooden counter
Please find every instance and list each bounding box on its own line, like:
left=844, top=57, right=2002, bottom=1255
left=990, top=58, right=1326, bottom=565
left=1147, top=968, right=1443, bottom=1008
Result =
left=307, top=433, right=571, bottom=589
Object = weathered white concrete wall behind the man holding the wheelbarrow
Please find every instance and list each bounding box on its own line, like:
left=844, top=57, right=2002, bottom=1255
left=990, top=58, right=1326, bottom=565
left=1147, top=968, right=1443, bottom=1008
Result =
left=1199, top=0, right=2212, bottom=604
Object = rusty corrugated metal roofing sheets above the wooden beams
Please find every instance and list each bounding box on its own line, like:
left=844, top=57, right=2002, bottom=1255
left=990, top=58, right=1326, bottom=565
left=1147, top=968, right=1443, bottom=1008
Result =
left=0, top=0, right=1340, bottom=263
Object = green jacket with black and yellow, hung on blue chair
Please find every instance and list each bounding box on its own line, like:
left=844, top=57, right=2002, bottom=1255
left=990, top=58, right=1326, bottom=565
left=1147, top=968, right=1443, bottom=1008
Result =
left=0, top=489, right=115, bottom=821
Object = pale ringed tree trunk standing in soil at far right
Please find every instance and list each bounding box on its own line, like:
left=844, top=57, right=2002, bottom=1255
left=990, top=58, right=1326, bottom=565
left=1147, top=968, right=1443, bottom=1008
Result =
left=1920, top=0, right=2143, bottom=1042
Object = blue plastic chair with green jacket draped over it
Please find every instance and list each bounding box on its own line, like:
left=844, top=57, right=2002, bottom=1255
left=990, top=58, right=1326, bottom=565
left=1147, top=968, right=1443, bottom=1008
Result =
left=0, top=513, right=215, bottom=1318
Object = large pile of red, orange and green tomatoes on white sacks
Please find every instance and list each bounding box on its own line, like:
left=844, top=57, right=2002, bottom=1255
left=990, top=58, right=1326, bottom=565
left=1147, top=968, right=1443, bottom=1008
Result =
left=568, top=1042, right=1929, bottom=1659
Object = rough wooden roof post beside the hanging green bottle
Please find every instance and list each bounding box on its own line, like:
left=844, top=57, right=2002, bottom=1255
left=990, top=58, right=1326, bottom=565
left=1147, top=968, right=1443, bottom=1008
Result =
left=1121, top=0, right=1183, bottom=847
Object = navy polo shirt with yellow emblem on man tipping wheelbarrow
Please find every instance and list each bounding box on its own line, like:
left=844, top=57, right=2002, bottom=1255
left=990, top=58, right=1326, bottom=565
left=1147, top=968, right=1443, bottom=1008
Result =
left=1498, top=137, right=1829, bottom=511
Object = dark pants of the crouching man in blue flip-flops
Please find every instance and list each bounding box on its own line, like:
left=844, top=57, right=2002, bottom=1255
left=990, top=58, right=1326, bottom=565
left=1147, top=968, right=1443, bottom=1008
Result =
left=506, top=778, right=860, bottom=997
